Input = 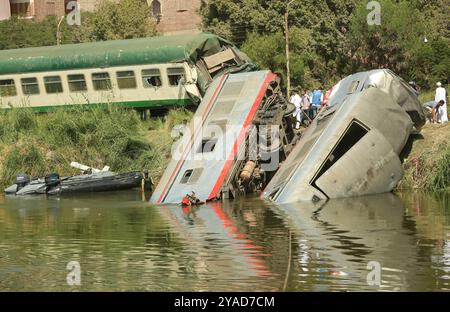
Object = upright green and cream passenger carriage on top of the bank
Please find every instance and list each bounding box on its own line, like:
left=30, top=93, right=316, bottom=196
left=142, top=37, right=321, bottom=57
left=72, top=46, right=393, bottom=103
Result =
left=0, top=33, right=256, bottom=111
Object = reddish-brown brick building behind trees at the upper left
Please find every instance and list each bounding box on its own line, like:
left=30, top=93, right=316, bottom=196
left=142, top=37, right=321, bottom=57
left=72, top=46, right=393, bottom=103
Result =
left=0, top=0, right=201, bottom=34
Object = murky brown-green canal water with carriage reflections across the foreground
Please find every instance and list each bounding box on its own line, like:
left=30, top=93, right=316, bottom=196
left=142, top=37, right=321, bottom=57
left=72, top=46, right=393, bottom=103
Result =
left=0, top=192, right=450, bottom=291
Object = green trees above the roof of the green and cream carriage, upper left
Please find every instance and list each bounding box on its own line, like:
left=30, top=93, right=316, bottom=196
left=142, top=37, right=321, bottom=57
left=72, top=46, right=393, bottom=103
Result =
left=0, top=0, right=156, bottom=50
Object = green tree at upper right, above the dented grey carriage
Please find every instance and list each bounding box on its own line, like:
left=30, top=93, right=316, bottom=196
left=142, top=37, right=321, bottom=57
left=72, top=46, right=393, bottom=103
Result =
left=347, top=0, right=450, bottom=88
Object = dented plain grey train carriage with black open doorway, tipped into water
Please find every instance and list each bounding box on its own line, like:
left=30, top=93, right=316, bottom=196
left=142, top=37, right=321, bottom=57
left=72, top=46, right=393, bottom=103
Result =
left=262, top=70, right=425, bottom=203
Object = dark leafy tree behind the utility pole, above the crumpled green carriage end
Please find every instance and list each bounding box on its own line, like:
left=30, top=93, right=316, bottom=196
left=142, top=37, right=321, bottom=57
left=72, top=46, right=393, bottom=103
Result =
left=200, top=0, right=357, bottom=86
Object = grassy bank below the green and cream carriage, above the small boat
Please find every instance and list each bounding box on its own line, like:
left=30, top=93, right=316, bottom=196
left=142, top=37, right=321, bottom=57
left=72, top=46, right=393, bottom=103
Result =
left=0, top=108, right=190, bottom=187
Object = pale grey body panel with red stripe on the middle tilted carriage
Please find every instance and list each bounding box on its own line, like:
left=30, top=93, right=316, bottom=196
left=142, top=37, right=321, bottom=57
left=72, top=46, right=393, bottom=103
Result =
left=150, top=71, right=276, bottom=204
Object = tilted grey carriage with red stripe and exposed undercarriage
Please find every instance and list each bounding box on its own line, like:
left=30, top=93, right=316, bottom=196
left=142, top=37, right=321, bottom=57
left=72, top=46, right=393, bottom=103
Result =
left=150, top=71, right=296, bottom=203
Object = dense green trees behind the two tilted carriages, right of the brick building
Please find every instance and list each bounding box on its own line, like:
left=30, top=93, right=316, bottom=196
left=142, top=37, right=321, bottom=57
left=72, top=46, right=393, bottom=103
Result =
left=200, top=0, right=450, bottom=89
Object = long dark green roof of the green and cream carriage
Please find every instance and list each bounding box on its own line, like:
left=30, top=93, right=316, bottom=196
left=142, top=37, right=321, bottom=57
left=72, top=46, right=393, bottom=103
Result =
left=0, top=33, right=241, bottom=75
